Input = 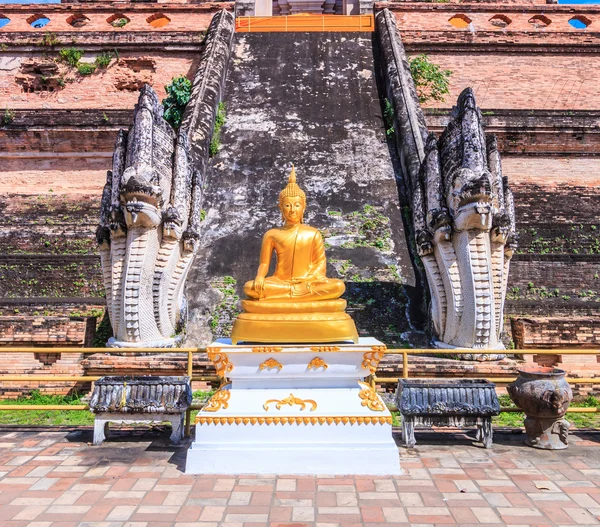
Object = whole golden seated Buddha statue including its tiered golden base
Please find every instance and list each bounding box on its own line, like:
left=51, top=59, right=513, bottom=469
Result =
left=231, top=166, right=358, bottom=344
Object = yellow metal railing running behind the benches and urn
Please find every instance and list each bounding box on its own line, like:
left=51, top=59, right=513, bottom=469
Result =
left=0, top=347, right=600, bottom=436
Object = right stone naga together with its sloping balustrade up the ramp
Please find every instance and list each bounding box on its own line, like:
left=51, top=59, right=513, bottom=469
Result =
left=376, top=9, right=517, bottom=359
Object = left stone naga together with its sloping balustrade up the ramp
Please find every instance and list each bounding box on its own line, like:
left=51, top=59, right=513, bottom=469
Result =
left=96, top=10, right=234, bottom=347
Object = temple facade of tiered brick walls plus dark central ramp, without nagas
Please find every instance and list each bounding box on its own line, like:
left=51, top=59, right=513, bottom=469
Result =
left=0, top=0, right=600, bottom=395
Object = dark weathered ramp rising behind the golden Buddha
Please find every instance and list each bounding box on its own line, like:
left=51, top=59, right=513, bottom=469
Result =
left=187, top=33, right=414, bottom=344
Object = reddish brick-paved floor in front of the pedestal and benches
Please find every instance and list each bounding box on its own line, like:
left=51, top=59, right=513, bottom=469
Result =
left=0, top=428, right=600, bottom=527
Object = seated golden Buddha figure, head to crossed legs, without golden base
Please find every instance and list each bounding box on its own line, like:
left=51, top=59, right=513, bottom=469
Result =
left=244, top=167, right=345, bottom=302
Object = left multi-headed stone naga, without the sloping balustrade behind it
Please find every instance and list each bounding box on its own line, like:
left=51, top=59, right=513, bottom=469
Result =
left=97, top=86, right=198, bottom=347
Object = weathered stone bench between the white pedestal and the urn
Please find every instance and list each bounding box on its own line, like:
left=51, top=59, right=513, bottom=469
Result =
left=396, top=379, right=500, bottom=448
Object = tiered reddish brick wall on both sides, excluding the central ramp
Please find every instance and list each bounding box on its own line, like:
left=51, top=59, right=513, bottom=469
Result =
left=0, top=0, right=600, bottom=388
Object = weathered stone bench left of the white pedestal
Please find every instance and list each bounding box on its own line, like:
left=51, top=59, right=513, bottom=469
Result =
left=90, top=376, right=192, bottom=445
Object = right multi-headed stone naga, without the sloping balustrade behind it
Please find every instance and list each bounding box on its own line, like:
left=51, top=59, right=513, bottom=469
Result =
left=413, top=89, right=516, bottom=349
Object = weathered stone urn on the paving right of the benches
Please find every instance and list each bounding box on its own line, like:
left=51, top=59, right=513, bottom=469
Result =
left=507, top=365, right=573, bottom=450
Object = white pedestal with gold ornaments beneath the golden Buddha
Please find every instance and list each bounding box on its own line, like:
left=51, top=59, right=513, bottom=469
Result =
left=185, top=338, right=402, bottom=475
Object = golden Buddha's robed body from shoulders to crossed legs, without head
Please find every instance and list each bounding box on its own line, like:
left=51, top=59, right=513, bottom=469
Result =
left=244, top=224, right=345, bottom=301
